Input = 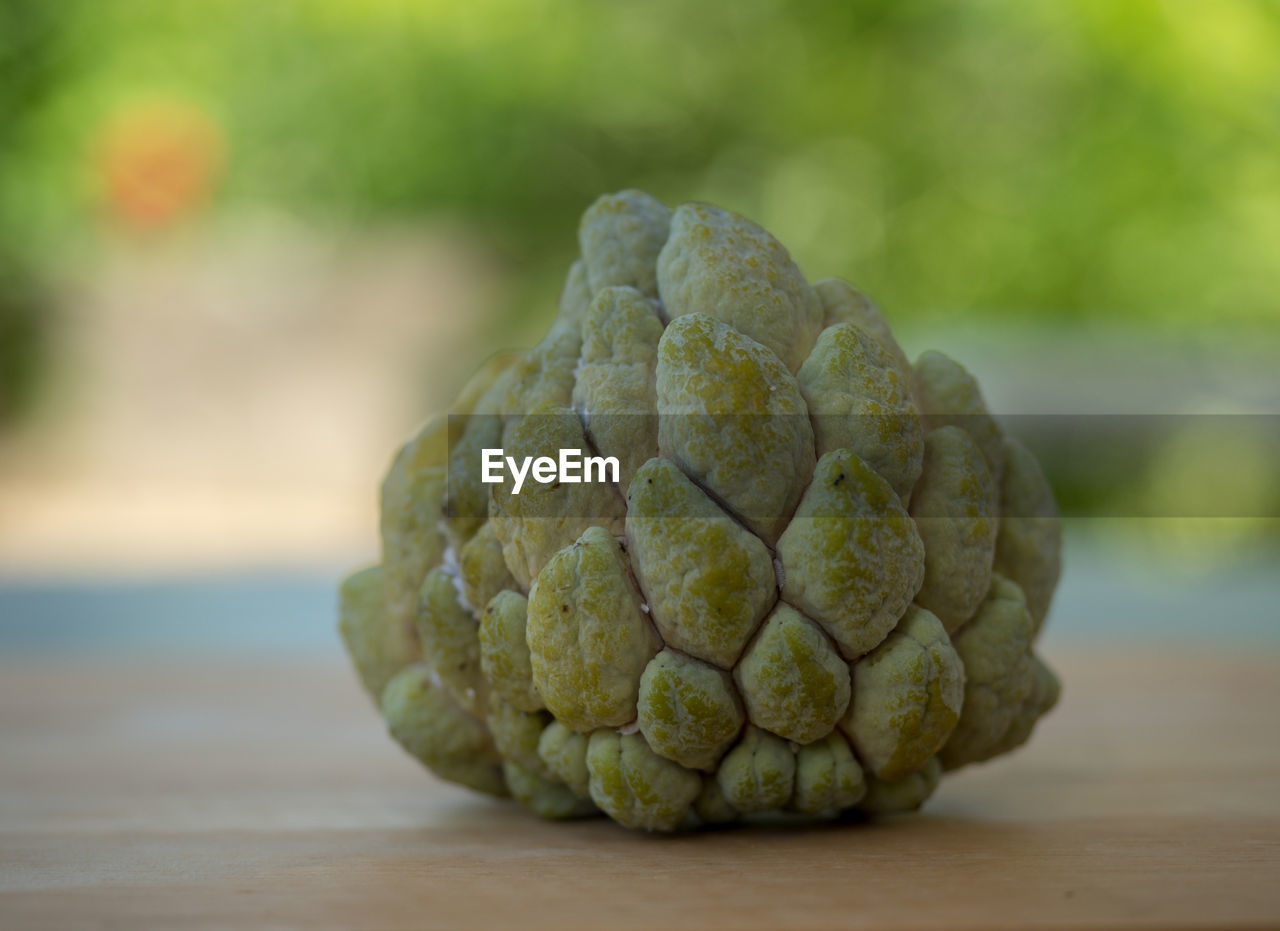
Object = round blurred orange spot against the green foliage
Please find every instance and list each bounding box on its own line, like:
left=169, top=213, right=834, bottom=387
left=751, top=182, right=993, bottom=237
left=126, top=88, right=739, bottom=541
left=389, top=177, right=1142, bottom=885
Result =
left=96, top=101, right=224, bottom=229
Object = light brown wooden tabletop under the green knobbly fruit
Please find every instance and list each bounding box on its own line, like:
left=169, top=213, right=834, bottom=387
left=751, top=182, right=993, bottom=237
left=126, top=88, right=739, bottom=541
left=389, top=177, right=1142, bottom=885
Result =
left=0, top=648, right=1280, bottom=931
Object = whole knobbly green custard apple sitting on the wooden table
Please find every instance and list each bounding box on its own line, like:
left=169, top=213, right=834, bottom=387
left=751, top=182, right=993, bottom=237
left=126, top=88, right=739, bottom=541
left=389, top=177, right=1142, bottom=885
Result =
left=340, top=191, right=1061, bottom=831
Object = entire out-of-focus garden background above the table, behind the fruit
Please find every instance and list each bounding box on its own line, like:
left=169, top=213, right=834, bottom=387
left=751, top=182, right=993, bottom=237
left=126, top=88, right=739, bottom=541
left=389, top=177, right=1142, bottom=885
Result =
left=0, top=0, right=1280, bottom=649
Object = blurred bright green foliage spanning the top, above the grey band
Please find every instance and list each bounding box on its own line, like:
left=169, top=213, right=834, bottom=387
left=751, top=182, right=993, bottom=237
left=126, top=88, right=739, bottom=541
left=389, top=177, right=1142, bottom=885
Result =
left=0, top=0, right=1280, bottom=338
